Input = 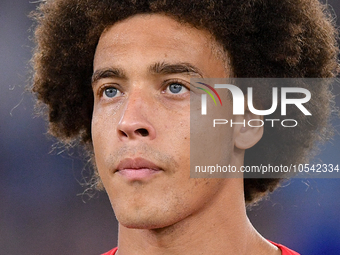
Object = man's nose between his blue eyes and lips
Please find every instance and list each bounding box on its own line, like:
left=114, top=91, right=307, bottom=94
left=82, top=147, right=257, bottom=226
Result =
left=117, top=90, right=156, bottom=140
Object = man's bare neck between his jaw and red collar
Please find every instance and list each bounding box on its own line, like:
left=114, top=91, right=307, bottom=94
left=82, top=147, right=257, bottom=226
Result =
left=117, top=179, right=280, bottom=255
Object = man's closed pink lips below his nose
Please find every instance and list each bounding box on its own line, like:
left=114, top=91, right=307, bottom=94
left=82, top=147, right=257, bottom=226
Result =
left=115, top=158, right=163, bottom=180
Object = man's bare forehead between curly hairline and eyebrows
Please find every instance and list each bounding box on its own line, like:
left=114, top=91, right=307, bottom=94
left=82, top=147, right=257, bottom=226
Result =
left=94, top=14, right=223, bottom=74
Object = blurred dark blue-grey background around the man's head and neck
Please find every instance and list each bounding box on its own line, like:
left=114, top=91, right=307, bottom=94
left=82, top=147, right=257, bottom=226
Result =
left=0, top=0, right=340, bottom=255
